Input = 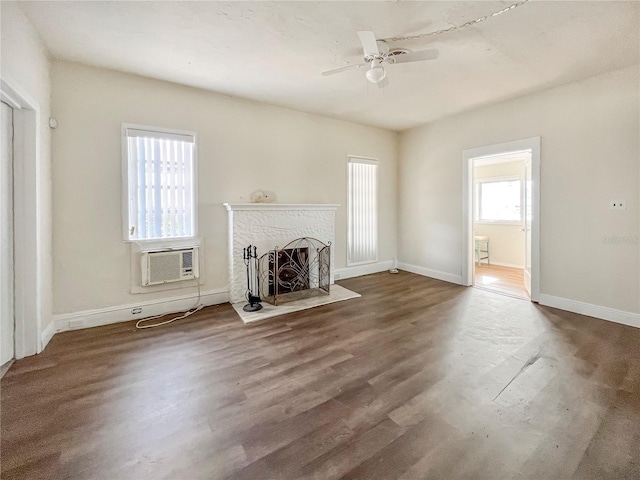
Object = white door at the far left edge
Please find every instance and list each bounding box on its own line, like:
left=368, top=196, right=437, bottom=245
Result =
left=0, top=103, right=15, bottom=365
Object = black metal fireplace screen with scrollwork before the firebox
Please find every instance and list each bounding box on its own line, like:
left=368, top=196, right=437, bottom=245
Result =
left=258, top=237, right=331, bottom=305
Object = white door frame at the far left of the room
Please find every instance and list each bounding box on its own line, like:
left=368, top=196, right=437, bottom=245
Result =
left=0, top=75, right=43, bottom=359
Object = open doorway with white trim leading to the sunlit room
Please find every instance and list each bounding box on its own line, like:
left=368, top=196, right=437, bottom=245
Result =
left=462, top=137, right=540, bottom=302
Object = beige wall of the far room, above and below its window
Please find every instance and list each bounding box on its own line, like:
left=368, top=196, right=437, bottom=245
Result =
left=473, top=161, right=525, bottom=268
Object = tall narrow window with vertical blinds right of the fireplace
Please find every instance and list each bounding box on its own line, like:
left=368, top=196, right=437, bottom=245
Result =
left=347, top=157, right=378, bottom=265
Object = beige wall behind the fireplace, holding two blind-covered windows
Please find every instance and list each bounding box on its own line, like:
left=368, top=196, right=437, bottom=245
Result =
left=53, top=62, right=398, bottom=313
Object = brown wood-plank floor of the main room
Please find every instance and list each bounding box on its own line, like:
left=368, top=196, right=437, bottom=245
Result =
left=1, top=272, right=640, bottom=480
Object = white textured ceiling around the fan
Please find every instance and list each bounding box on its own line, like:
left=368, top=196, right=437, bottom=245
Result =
left=15, top=0, right=640, bottom=130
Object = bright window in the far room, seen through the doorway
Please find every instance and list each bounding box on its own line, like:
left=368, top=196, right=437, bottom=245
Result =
left=476, top=179, right=522, bottom=223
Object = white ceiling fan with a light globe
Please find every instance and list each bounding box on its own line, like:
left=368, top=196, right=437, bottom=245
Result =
left=322, top=31, right=438, bottom=85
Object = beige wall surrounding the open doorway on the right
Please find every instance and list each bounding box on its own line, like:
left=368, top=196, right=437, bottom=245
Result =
left=398, top=65, right=640, bottom=313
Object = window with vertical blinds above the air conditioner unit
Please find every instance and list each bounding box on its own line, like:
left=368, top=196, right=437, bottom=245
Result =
left=123, top=125, right=196, bottom=240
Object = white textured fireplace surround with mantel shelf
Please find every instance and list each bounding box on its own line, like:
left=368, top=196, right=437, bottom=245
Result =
left=223, top=203, right=340, bottom=303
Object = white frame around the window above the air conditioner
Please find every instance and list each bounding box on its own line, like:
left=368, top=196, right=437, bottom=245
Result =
left=122, top=123, right=198, bottom=246
